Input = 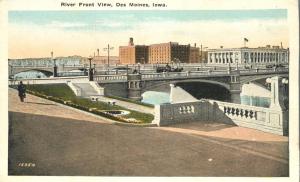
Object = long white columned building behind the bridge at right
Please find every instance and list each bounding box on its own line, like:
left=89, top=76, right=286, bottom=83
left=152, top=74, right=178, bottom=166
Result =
left=207, top=45, right=289, bottom=64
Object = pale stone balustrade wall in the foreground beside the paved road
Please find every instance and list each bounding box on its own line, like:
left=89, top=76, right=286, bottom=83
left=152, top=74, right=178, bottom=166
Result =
left=153, top=100, right=288, bottom=135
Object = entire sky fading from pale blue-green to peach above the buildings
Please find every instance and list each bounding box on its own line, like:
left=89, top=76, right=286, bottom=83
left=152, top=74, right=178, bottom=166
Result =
left=8, top=9, right=288, bottom=58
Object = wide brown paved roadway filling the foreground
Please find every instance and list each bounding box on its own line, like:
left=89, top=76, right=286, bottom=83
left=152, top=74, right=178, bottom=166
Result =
left=9, top=89, right=289, bottom=176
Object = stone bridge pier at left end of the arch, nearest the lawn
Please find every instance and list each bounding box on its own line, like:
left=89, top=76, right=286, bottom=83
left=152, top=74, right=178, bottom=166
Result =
left=127, top=74, right=142, bottom=101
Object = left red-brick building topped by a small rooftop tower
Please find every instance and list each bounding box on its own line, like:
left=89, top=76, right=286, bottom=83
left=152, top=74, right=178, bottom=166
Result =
left=119, top=38, right=149, bottom=64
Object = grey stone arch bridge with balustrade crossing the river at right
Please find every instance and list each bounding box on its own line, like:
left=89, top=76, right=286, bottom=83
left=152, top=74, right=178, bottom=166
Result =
left=94, top=68, right=288, bottom=103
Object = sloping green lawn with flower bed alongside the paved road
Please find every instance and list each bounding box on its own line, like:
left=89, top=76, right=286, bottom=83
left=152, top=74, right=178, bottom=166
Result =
left=26, top=84, right=154, bottom=123
